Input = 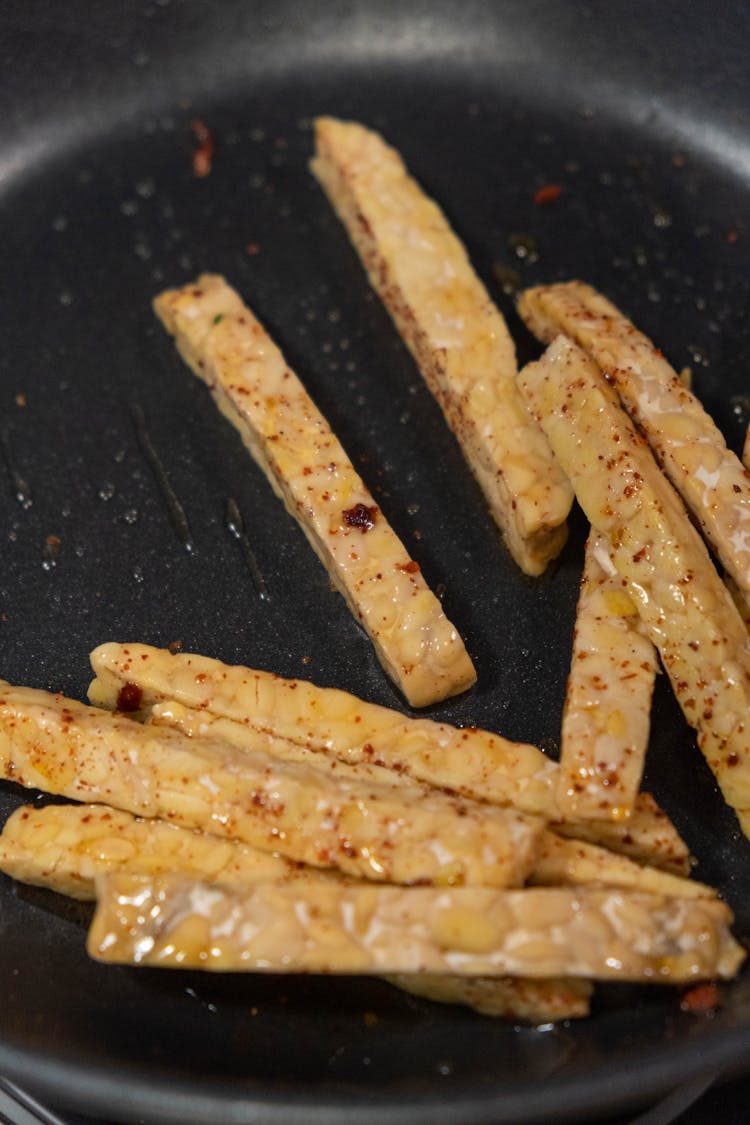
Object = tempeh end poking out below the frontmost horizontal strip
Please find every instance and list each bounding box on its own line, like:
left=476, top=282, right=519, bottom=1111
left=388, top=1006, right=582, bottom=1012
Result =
left=387, top=973, right=593, bottom=1024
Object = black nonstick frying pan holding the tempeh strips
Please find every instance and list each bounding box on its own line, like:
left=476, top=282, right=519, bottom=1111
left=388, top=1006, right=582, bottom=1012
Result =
left=0, top=0, right=750, bottom=1123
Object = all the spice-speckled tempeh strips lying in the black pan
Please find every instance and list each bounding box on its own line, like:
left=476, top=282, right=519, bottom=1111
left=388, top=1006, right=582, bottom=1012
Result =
left=0, top=118, right=750, bottom=1022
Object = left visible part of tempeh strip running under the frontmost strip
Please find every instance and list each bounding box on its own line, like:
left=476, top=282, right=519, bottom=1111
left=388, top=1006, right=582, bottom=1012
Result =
left=0, top=804, right=299, bottom=899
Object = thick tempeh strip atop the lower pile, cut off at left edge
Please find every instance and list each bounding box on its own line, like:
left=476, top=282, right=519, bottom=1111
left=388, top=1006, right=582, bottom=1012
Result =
left=0, top=684, right=543, bottom=885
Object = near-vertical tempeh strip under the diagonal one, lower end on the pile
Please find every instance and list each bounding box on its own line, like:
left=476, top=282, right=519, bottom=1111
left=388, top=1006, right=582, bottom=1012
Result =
left=558, top=531, right=657, bottom=820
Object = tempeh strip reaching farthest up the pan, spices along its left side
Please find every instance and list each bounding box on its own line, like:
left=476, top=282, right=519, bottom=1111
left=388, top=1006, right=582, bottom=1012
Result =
left=310, top=117, right=572, bottom=574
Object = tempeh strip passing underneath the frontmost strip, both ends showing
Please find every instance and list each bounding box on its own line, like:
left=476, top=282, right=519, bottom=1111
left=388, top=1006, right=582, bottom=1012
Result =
left=0, top=804, right=590, bottom=1023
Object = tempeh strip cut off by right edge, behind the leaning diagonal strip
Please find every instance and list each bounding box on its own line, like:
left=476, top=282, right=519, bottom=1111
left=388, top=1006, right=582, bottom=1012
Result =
left=518, top=281, right=750, bottom=597
